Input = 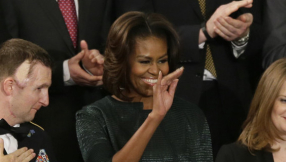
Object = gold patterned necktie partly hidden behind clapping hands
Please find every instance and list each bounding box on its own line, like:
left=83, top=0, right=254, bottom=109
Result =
left=198, top=0, right=217, bottom=77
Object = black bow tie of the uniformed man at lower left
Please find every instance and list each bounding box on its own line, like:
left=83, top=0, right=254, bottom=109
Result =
left=0, top=119, right=29, bottom=141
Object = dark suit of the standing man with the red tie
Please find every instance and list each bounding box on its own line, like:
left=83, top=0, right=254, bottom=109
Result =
left=0, top=0, right=107, bottom=161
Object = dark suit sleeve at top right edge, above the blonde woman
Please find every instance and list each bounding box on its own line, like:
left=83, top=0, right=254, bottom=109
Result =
left=263, top=0, right=286, bottom=69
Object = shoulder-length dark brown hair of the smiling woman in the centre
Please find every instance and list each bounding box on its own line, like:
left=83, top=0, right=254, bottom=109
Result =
left=103, top=11, right=179, bottom=101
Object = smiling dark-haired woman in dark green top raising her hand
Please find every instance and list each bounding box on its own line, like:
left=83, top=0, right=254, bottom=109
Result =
left=76, top=12, right=212, bottom=162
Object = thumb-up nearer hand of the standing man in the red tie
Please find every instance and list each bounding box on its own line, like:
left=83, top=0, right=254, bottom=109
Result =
left=68, top=41, right=103, bottom=86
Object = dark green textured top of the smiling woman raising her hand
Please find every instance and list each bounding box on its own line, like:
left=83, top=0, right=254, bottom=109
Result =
left=76, top=96, right=212, bottom=162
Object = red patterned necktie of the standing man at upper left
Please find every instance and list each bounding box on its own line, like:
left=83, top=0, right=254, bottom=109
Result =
left=58, top=0, right=77, bottom=48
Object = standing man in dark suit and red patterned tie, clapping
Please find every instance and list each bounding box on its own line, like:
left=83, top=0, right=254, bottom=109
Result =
left=0, top=0, right=108, bottom=162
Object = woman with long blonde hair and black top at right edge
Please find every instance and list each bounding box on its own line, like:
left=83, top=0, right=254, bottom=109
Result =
left=216, top=58, right=286, bottom=162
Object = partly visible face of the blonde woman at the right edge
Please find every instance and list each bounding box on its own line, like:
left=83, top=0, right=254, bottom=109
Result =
left=271, top=81, right=286, bottom=136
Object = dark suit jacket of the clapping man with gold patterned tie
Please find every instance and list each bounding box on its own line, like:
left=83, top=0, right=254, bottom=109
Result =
left=108, top=0, right=261, bottom=141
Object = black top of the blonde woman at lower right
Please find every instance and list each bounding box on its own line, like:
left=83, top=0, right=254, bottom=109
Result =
left=216, top=143, right=274, bottom=162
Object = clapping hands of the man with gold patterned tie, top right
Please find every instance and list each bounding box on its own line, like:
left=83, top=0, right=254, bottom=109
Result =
left=206, top=0, right=253, bottom=40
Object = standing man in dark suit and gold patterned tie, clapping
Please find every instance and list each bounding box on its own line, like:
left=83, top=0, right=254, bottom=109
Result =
left=109, top=0, right=261, bottom=156
